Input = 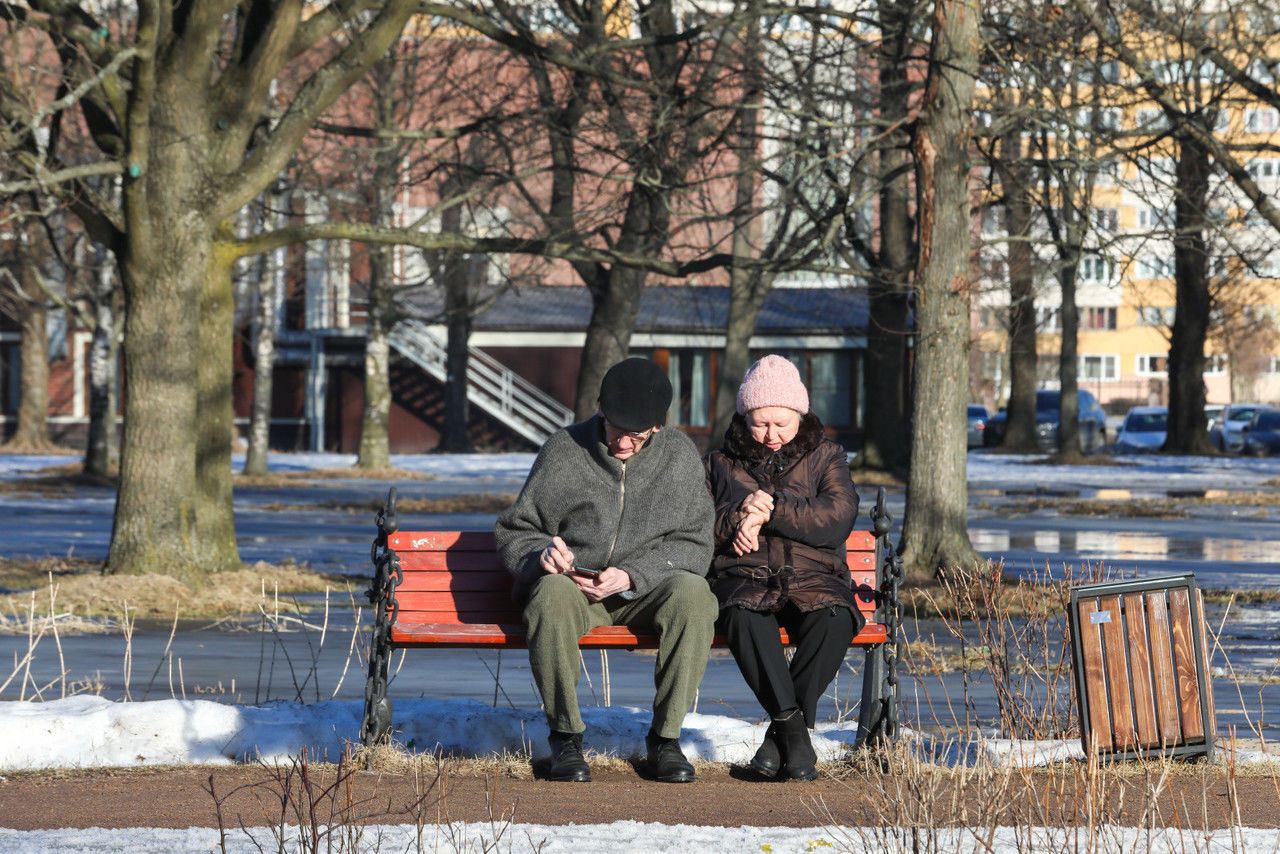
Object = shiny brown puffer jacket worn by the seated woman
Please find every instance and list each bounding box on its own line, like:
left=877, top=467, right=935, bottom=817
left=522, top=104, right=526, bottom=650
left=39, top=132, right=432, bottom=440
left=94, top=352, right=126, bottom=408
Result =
left=704, top=412, right=863, bottom=629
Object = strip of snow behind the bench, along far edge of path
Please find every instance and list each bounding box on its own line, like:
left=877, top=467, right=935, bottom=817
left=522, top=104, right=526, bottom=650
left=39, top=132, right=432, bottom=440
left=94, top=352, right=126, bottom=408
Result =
left=0, top=695, right=1268, bottom=772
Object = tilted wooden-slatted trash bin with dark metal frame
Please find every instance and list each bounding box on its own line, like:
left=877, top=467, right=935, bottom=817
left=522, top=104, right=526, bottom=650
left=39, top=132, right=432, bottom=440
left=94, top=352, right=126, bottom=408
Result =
left=1068, top=572, right=1216, bottom=758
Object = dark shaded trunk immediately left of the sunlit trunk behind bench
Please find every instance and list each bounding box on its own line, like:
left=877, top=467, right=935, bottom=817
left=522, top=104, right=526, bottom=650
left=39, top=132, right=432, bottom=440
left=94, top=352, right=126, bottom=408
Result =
left=861, top=0, right=915, bottom=470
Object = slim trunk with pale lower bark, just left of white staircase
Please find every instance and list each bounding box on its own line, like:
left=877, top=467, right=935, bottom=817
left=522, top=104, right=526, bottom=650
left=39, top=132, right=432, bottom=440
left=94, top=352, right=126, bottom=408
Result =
left=356, top=247, right=392, bottom=469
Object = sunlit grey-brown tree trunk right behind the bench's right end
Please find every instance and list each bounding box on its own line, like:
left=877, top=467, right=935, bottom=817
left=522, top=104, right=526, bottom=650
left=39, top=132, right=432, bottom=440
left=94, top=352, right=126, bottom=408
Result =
left=902, top=1, right=980, bottom=579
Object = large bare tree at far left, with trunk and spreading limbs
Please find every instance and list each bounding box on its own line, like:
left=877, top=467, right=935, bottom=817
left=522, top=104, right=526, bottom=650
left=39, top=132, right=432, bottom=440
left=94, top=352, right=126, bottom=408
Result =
left=0, top=0, right=416, bottom=577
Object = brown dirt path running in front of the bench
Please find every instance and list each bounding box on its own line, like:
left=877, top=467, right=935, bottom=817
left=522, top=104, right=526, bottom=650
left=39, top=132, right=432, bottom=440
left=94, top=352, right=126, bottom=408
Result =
left=0, top=763, right=1280, bottom=830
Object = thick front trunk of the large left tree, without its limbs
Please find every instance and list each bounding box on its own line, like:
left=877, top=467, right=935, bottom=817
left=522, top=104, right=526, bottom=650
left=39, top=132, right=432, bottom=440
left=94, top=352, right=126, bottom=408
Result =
left=106, top=79, right=209, bottom=581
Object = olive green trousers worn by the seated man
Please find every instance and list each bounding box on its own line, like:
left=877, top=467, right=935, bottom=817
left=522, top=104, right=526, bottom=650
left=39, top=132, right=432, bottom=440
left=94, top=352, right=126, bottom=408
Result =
left=525, top=572, right=719, bottom=739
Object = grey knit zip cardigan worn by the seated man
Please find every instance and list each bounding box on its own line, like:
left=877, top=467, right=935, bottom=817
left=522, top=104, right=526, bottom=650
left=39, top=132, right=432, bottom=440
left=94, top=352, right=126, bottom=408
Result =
left=494, top=415, right=716, bottom=598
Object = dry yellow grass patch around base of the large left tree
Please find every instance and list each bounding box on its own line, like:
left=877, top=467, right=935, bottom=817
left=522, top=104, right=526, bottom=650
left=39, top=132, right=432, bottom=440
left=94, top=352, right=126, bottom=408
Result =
left=0, top=562, right=347, bottom=632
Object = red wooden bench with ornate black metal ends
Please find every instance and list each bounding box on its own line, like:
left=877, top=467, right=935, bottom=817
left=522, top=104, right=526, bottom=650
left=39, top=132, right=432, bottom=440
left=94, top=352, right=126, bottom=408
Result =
left=360, top=488, right=900, bottom=744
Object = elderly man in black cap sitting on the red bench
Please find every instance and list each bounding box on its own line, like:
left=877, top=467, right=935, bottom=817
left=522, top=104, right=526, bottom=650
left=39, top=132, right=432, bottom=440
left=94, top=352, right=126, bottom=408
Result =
left=494, top=359, right=718, bottom=782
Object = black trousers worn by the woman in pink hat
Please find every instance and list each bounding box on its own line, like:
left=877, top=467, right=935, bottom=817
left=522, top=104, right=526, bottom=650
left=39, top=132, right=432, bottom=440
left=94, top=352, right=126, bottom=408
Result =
left=719, top=604, right=854, bottom=727
